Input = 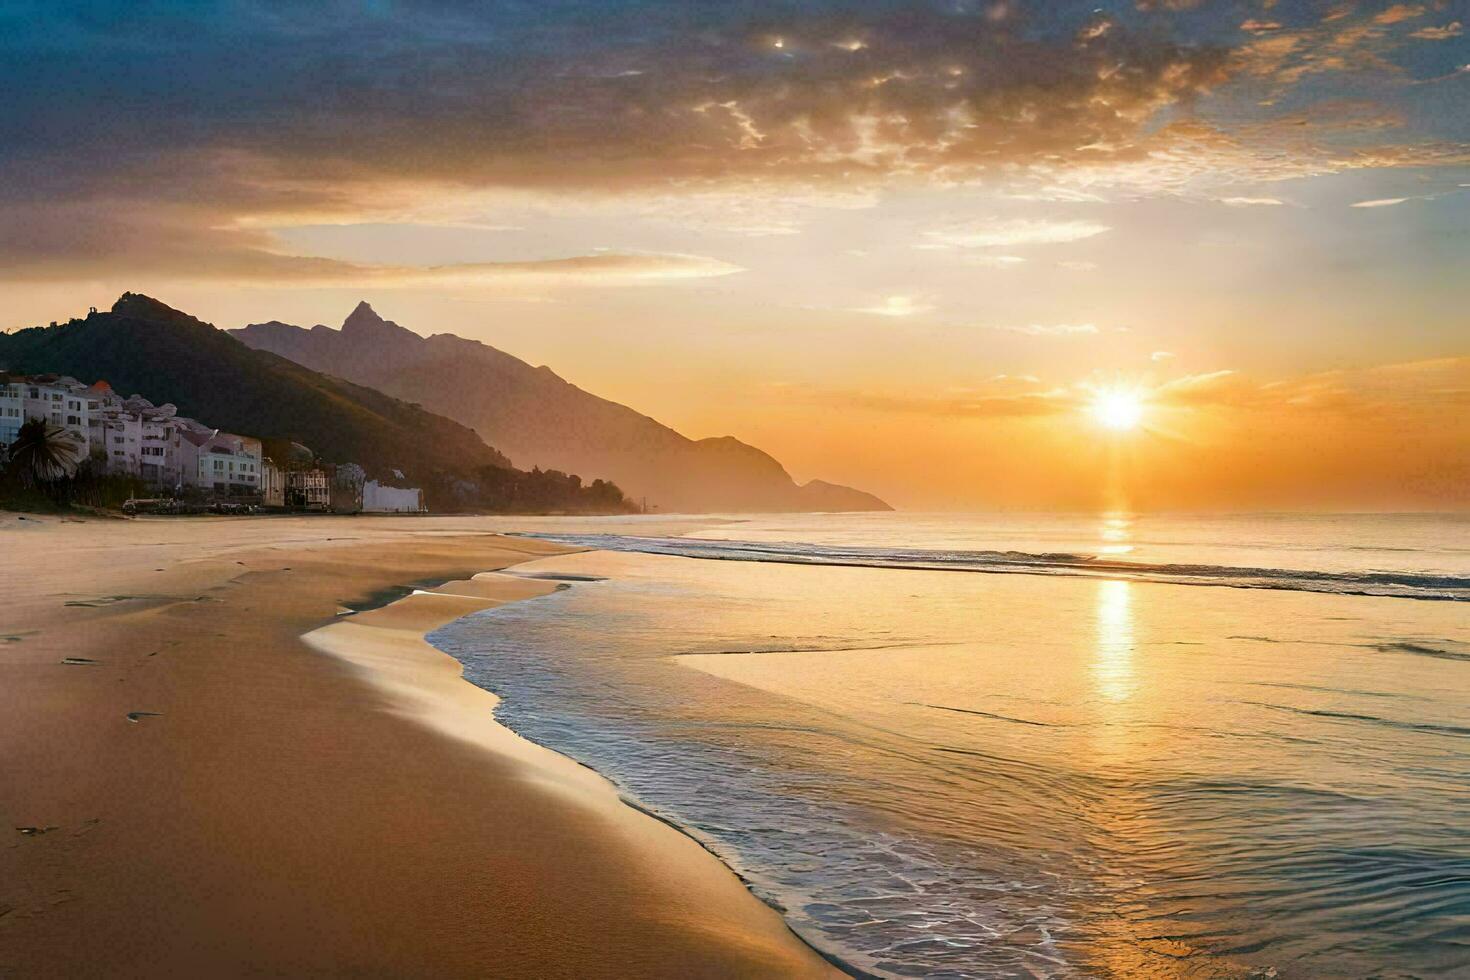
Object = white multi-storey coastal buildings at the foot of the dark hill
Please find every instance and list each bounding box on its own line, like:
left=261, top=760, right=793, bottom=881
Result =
left=0, top=373, right=426, bottom=514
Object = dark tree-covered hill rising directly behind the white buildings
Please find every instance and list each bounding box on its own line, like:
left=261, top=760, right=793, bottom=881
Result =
left=0, top=292, right=629, bottom=510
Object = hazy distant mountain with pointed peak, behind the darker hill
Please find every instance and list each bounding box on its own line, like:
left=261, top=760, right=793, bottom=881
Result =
left=231, top=303, right=892, bottom=513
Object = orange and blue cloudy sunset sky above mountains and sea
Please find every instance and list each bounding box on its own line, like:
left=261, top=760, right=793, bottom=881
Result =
left=0, top=0, right=1470, bottom=510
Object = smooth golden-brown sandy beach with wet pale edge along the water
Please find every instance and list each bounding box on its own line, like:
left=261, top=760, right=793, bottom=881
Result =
left=0, top=514, right=836, bottom=977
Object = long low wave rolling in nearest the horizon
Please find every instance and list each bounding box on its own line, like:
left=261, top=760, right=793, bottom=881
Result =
left=525, top=533, right=1470, bottom=602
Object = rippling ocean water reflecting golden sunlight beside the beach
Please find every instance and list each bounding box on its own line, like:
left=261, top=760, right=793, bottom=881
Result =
left=431, top=514, right=1470, bottom=977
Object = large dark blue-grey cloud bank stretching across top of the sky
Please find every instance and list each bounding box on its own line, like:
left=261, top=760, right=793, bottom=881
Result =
left=0, top=0, right=1452, bottom=275
